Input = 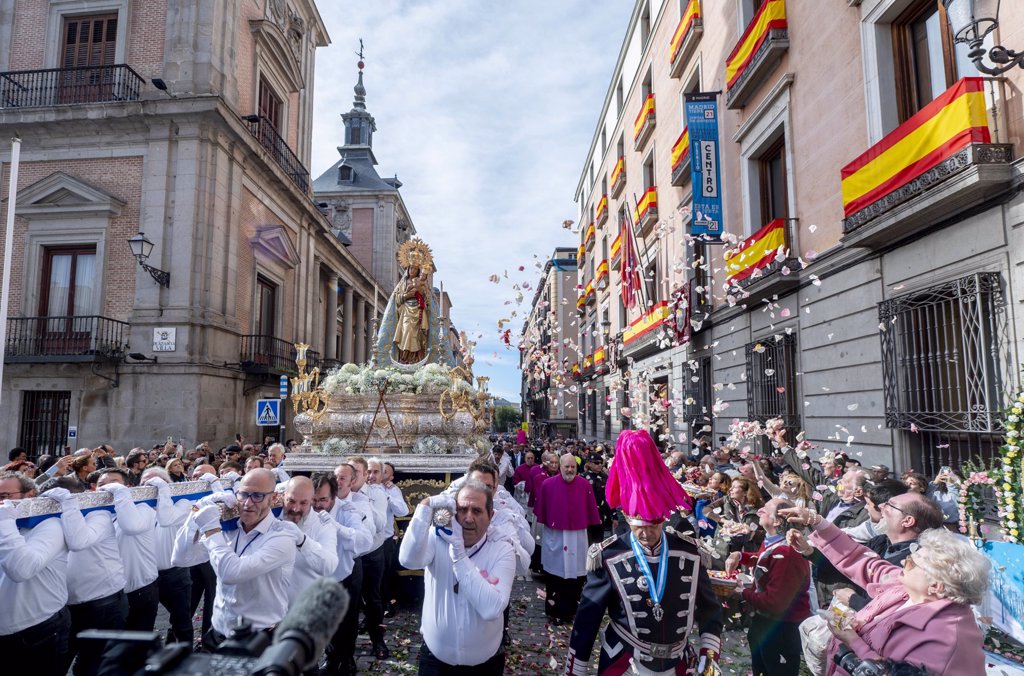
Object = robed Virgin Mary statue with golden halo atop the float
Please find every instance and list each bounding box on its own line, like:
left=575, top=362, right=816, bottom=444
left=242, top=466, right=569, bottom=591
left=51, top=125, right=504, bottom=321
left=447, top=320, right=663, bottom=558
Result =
left=374, top=234, right=453, bottom=366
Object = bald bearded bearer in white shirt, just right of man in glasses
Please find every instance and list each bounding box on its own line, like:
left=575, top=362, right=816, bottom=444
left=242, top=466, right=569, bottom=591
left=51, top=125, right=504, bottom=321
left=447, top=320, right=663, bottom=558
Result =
left=281, top=476, right=338, bottom=607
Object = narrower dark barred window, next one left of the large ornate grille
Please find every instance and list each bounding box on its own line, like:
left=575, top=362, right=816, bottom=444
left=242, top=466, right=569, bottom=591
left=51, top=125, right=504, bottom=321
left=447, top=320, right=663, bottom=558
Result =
left=746, top=334, right=801, bottom=440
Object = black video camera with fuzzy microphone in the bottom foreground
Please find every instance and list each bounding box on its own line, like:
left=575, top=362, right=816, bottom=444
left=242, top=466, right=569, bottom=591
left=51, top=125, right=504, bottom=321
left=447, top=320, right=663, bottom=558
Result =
left=79, top=578, right=349, bottom=676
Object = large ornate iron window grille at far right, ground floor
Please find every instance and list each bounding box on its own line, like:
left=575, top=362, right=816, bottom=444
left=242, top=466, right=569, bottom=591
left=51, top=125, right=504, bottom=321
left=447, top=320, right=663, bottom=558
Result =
left=879, top=272, right=1006, bottom=474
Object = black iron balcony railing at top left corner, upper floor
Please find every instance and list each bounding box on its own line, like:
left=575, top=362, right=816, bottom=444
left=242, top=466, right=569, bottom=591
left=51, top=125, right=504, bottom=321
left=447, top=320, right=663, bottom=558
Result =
left=0, top=64, right=144, bottom=109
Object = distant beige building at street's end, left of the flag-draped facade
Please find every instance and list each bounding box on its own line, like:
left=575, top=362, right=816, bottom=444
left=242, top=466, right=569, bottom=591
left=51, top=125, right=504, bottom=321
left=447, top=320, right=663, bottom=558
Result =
left=519, top=248, right=579, bottom=438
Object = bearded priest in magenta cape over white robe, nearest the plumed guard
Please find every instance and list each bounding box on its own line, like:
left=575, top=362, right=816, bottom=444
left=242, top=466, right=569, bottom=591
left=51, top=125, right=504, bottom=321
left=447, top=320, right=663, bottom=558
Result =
left=534, top=453, right=601, bottom=625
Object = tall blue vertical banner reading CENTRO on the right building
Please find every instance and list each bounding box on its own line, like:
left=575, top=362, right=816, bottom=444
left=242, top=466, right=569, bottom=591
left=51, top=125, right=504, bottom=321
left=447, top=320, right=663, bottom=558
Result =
left=686, top=91, right=722, bottom=242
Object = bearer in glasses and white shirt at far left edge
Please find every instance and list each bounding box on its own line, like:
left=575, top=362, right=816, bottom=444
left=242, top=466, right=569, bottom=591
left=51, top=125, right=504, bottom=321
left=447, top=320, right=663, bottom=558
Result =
left=0, top=472, right=77, bottom=676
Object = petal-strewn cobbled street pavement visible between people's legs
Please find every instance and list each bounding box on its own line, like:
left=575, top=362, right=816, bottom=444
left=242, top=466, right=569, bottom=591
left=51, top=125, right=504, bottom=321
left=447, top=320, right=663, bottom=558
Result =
left=157, top=578, right=751, bottom=676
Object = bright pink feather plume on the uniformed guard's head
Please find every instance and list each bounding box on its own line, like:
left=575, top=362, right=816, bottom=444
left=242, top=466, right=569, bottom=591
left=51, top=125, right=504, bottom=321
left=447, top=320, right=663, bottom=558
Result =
left=604, top=430, right=693, bottom=524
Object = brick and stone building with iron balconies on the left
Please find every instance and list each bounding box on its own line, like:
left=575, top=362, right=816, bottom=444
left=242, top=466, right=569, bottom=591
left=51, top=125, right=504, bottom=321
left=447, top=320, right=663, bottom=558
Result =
left=0, top=0, right=389, bottom=454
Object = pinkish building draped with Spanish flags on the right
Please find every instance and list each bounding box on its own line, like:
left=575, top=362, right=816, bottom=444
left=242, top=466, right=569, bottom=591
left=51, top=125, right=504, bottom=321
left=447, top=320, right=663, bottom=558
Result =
left=575, top=0, right=1024, bottom=473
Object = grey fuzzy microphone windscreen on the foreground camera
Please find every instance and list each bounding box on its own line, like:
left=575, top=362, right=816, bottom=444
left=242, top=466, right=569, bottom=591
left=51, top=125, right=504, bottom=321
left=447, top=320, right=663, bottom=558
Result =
left=252, top=578, right=349, bottom=676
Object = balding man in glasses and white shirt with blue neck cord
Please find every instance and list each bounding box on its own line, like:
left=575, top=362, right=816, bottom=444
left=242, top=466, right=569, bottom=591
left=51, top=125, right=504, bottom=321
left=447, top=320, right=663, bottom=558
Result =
left=175, top=469, right=305, bottom=647
